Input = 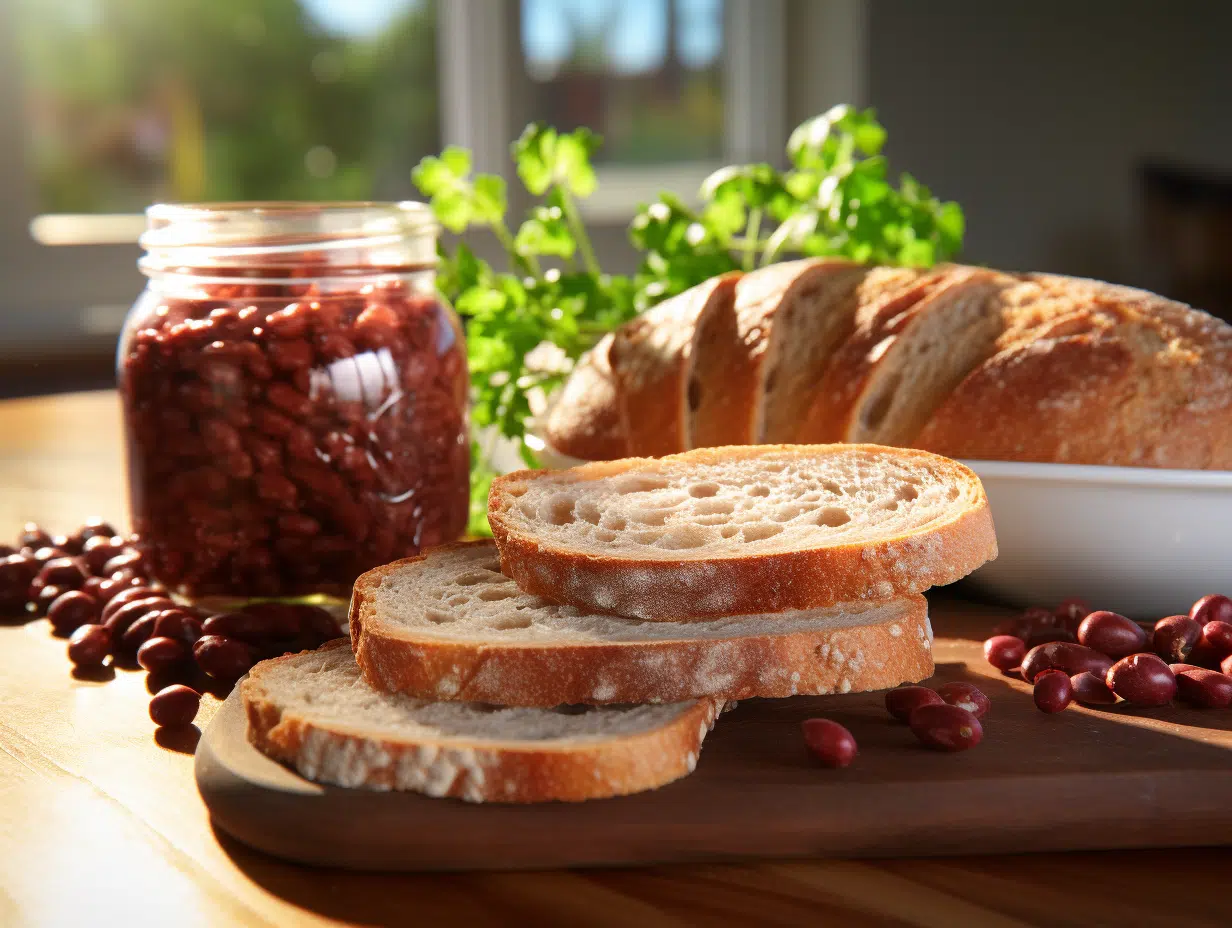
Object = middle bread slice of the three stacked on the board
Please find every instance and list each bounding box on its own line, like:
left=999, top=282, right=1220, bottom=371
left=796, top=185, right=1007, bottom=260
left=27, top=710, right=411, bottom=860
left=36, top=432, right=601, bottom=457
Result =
left=351, top=541, right=933, bottom=706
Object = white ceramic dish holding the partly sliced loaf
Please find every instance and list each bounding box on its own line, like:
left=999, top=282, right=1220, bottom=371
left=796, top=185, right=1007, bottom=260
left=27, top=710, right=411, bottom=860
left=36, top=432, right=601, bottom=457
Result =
left=541, top=449, right=1232, bottom=619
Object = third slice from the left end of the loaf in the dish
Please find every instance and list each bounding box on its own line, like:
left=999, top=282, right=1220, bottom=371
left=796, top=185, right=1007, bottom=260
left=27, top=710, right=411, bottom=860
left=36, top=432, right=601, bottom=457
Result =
left=678, top=259, right=865, bottom=450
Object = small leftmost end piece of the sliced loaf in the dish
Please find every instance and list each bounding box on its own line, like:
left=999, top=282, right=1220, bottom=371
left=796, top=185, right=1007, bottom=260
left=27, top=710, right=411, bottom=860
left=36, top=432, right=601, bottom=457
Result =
left=545, top=334, right=631, bottom=461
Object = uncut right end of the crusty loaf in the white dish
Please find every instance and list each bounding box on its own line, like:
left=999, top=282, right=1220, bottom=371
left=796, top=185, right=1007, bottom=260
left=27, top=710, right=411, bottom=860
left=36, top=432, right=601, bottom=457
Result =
left=914, top=275, right=1232, bottom=470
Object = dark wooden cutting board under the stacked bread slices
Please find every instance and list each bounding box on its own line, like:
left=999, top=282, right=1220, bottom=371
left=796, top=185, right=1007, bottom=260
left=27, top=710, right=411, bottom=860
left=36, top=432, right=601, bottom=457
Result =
left=196, top=601, right=1232, bottom=870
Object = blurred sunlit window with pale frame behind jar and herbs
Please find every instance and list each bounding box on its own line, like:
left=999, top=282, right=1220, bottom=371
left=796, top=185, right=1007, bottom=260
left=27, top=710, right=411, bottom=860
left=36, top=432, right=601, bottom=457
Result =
left=0, top=0, right=865, bottom=351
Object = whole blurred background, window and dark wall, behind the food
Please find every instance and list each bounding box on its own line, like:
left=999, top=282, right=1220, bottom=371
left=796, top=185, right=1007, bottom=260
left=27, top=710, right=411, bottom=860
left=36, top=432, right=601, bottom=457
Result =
left=0, top=0, right=1232, bottom=394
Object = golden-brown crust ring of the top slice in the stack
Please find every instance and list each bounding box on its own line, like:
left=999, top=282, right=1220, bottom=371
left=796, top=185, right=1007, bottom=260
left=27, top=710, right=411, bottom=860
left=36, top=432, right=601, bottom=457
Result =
left=488, top=445, right=997, bottom=621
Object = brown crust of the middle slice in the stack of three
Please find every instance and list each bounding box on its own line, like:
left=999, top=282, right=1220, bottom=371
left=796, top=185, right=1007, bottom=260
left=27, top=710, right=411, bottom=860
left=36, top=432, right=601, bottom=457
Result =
left=351, top=541, right=933, bottom=706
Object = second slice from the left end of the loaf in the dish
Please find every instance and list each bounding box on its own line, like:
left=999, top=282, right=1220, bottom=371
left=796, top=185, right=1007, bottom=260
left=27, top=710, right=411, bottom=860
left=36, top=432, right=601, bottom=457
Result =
left=611, top=274, right=739, bottom=457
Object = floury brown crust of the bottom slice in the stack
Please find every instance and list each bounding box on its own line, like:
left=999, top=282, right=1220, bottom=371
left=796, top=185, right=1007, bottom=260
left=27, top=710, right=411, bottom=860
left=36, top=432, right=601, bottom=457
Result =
left=240, top=640, right=721, bottom=802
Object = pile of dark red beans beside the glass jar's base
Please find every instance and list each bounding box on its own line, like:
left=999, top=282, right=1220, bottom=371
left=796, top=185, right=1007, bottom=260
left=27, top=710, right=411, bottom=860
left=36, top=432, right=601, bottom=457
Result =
left=0, top=519, right=341, bottom=726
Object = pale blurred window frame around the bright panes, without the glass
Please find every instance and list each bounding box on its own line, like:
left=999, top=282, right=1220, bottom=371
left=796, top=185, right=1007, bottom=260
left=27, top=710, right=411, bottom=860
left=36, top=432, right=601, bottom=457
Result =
left=0, top=0, right=869, bottom=340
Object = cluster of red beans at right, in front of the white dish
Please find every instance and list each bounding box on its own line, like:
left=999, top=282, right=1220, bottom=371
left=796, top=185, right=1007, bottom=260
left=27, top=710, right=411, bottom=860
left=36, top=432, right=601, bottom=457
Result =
left=984, top=594, right=1232, bottom=712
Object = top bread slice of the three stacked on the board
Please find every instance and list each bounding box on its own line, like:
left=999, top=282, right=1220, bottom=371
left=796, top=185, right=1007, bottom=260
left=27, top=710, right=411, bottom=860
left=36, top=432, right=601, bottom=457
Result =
left=488, top=445, right=997, bottom=621
